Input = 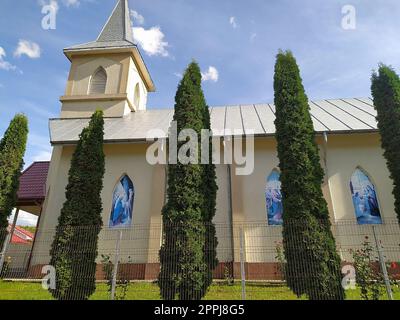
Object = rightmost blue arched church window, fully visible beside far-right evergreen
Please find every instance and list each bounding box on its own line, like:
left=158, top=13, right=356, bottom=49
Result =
left=350, top=168, right=382, bottom=224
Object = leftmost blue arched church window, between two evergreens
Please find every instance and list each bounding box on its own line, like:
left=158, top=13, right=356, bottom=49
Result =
left=109, top=175, right=135, bottom=228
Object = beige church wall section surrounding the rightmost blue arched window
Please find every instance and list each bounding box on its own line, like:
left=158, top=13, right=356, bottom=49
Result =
left=327, top=133, right=400, bottom=261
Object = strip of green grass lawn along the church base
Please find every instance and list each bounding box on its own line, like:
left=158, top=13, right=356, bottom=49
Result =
left=0, top=281, right=400, bottom=300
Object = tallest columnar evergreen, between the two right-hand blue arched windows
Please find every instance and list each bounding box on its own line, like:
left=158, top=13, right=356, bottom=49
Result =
left=274, top=52, right=344, bottom=300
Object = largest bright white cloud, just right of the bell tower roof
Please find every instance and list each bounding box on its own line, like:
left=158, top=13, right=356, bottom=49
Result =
left=133, top=27, right=169, bottom=57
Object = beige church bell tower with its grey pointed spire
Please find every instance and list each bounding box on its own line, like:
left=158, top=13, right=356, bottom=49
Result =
left=60, top=0, right=155, bottom=118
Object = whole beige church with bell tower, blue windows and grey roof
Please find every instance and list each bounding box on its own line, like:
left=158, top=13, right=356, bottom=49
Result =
left=31, top=0, right=399, bottom=279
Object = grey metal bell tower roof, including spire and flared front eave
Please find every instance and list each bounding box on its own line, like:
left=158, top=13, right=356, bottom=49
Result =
left=64, top=0, right=136, bottom=52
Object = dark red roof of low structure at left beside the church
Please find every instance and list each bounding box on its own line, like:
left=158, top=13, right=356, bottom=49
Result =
left=18, top=161, right=50, bottom=200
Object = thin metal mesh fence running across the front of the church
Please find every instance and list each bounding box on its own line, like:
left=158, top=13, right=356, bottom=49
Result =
left=0, top=220, right=400, bottom=300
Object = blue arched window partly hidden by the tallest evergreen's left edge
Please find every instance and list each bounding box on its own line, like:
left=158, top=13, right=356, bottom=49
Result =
left=265, top=169, right=283, bottom=226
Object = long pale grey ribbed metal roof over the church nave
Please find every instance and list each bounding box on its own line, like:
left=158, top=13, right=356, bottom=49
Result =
left=50, top=98, right=377, bottom=144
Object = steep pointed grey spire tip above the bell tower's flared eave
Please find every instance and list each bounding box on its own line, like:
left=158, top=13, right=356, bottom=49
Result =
left=97, top=0, right=133, bottom=43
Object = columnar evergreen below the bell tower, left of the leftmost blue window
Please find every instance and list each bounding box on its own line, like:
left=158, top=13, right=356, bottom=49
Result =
left=50, top=111, right=105, bottom=300
